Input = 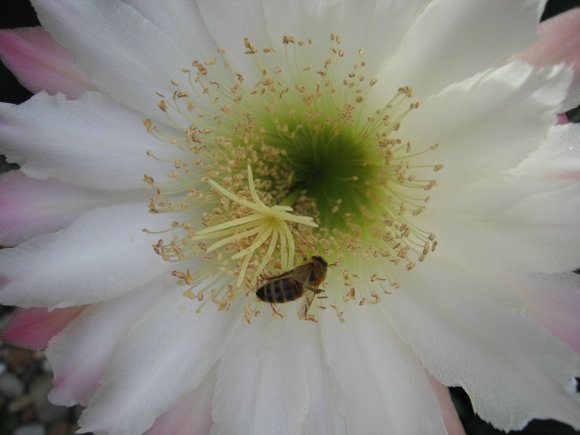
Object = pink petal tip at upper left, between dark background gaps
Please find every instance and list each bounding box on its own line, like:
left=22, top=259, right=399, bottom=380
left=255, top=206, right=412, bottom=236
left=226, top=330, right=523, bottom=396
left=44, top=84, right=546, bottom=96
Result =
left=0, top=27, right=96, bottom=98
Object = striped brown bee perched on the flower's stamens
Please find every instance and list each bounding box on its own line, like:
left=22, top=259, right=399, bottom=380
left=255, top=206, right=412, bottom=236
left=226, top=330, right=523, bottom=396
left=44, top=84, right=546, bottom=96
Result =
left=256, top=256, right=328, bottom=304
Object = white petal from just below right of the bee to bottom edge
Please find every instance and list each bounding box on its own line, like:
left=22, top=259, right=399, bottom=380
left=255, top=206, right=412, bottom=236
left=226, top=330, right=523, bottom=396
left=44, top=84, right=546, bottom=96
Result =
left=321, top=304, right=447, bottom=435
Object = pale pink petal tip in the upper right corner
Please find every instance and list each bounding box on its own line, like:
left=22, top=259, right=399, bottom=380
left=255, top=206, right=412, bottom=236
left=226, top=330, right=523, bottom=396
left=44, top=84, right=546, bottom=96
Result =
left=519, top=8, right=580, bottom=110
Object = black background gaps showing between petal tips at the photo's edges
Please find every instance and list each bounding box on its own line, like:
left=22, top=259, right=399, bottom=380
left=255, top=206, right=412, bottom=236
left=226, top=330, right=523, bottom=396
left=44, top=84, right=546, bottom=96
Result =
left=0, top=0, right=580, bottom=435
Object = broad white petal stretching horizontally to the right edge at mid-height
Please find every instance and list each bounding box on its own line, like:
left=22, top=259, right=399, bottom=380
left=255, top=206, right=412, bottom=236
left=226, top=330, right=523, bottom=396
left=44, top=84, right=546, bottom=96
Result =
left=417, top=172, right=580, bottom=273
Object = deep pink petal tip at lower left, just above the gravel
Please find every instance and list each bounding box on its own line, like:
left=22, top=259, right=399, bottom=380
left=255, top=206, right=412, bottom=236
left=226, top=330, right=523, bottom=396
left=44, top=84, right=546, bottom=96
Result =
left=2, top=306, right=85, bottom=349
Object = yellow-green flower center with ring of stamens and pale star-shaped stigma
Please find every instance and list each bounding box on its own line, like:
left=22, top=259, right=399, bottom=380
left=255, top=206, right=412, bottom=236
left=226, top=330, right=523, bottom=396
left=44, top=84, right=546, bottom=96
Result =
left=144, top=34, right=442, bottom=318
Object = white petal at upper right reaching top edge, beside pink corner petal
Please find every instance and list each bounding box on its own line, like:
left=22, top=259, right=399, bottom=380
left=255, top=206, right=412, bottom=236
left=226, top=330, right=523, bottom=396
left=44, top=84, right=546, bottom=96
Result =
left=381, top=0, right=546, bottom=99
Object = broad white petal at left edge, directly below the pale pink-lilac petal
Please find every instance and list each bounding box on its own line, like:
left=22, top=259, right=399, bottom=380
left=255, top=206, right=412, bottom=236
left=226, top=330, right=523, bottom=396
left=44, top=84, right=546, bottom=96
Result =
left=0, top=203, right=171, bottom=308
